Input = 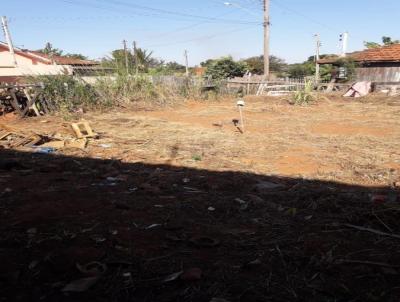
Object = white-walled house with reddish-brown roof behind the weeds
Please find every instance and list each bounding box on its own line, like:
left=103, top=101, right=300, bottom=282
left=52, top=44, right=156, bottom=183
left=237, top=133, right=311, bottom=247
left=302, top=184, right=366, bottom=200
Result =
left=0, top=42, right=99, bottom=82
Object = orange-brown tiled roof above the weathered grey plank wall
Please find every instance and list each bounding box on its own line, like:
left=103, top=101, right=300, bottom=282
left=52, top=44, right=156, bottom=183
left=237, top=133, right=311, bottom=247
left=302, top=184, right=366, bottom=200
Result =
left=318, top=44, right=400, bottom=64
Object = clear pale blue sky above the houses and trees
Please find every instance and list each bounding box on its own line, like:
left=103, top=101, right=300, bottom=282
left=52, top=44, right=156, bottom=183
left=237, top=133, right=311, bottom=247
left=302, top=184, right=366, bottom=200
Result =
left=0, top=0, right=400, bottom=65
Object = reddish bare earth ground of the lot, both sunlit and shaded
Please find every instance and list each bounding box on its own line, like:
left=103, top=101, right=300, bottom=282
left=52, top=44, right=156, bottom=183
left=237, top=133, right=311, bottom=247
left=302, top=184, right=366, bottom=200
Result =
left=0, top=96, right=400, bottom=302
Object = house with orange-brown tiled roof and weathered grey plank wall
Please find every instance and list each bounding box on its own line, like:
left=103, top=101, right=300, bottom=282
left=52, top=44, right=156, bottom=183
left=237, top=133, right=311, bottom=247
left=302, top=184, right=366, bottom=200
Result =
left=318, top=44, right=400, bottom=85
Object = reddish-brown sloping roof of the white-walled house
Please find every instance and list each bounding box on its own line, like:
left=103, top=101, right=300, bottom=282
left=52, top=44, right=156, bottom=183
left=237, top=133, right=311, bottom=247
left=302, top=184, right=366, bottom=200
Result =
left=0, top=42, right=98, bottom=66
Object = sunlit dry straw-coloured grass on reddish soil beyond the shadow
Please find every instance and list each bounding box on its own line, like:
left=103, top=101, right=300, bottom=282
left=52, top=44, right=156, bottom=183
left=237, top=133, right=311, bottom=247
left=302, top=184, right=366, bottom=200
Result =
left=7, top=92, right=400, bottom=185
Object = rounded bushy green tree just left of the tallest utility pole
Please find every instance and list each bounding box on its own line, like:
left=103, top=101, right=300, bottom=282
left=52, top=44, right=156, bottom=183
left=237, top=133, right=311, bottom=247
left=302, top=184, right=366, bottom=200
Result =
left=206, top=57, right=248, bottom=79
